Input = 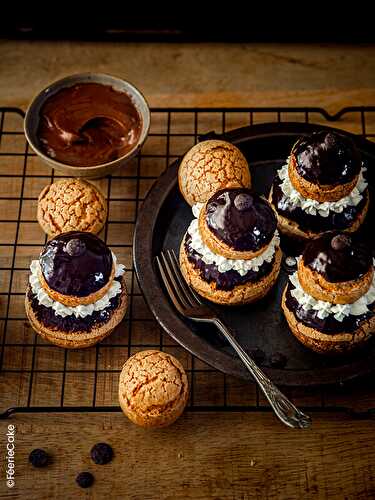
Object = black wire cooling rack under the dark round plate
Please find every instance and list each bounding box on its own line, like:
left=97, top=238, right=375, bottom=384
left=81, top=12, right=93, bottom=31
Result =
left=0, top=107, right=375, bottom=418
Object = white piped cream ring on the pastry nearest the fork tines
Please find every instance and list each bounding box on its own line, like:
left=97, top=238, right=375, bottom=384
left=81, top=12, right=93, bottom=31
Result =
left=188, top=203, right=280, bottom=276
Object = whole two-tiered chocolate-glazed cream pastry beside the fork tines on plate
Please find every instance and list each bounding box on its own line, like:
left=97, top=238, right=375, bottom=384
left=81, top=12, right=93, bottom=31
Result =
left=180, top=188, right=282, bottom=305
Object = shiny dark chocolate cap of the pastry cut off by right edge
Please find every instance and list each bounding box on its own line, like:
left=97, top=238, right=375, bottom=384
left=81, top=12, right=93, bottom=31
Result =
left=302, top=233, right=372, bottom=283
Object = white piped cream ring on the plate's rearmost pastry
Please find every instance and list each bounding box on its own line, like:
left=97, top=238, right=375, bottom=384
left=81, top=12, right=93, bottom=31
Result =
left=277, top=158, right=367, bottom=217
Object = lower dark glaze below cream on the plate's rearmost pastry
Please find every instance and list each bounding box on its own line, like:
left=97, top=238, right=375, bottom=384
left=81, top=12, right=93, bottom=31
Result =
left=272, top=176, right=368, bottom=233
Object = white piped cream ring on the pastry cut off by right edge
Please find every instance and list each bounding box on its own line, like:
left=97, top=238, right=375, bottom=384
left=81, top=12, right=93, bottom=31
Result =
left=289, top=271, right=375, bottom=321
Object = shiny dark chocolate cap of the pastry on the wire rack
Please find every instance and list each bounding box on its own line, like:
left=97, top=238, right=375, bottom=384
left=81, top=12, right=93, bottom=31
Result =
left=39, top=231, right=112, bottom=297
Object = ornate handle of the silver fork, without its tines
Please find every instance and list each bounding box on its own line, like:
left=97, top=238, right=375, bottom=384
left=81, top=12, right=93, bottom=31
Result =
left=214, top=318, right=311, bottom=429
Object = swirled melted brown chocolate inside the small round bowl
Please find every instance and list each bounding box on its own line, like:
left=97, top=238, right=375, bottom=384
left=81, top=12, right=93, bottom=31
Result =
left=38, top=83, right=142, bottom=167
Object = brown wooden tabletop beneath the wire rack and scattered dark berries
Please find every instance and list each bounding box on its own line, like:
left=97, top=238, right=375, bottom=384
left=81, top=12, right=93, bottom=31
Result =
left=0, top=41, right=375, bottom=500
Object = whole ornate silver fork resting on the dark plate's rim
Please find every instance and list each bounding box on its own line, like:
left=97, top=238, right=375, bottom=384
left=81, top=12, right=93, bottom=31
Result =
left=156, top=250, right=311, bottom=429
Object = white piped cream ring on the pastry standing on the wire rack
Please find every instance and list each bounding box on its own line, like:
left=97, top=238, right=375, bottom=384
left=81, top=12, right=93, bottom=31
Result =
left=29, top=252, right=125, bottom=318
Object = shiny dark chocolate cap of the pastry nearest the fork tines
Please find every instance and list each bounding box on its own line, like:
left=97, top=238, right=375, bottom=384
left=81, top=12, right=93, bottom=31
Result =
left=206, top=188, right=277, bottom=251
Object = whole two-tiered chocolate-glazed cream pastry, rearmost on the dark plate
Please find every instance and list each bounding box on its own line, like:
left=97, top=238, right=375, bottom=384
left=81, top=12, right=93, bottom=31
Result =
left=269, top=131, right=369, bottom=239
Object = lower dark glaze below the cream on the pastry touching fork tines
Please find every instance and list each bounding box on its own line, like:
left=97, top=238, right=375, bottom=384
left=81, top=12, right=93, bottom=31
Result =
left=185, top=233, right=275, bottom=291
